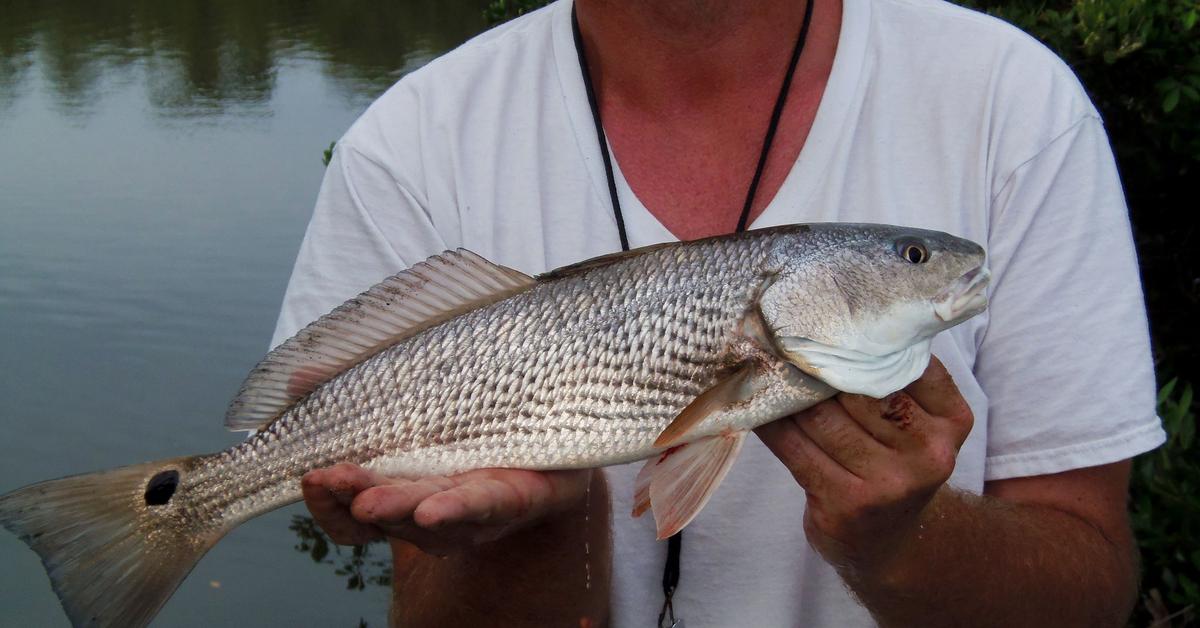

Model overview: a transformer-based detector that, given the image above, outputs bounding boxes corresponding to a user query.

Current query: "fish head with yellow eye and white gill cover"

[758,223,990,397]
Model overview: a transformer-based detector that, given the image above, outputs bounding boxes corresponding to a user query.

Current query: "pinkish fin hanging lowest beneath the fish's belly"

[634,430,746,540]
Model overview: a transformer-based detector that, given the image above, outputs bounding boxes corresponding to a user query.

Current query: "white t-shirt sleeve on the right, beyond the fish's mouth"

[976,115,1165,480]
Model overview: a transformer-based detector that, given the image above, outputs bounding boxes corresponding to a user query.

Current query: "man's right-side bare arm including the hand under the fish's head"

[758,359,1136,627]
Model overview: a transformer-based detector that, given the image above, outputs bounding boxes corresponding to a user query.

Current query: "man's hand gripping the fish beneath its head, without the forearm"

[757,358,973,572]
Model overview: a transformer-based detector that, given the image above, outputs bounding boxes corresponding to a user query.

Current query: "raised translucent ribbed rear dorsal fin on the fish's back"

[226,249,535,430]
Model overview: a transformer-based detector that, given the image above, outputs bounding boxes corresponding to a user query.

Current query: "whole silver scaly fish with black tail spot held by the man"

[0,225,986,626]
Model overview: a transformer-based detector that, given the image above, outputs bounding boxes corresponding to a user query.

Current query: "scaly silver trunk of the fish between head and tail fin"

[206,228,832,516]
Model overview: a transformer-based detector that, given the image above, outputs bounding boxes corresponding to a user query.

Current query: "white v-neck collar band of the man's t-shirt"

[551,0,871,247]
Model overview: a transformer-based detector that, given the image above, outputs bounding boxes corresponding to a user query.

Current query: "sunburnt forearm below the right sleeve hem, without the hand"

[839,486,1136,627]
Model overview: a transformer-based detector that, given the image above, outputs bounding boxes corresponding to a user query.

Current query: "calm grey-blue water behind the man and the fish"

[0,0,484,627]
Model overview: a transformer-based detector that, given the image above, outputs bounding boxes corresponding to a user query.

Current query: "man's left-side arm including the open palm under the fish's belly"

[304,465,612,628]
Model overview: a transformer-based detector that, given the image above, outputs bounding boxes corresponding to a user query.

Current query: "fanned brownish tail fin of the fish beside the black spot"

[0,456,227,627]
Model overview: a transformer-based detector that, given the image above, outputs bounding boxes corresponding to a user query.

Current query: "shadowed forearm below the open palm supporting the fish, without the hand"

[391,472,612,627]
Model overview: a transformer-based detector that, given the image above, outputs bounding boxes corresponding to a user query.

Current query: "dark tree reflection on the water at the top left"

[0,0,482,115]
